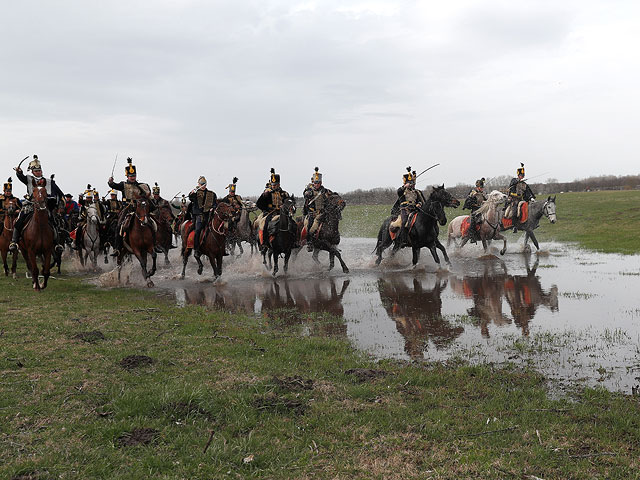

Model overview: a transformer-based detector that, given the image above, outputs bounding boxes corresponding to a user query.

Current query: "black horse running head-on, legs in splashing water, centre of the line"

[262,196,298,277]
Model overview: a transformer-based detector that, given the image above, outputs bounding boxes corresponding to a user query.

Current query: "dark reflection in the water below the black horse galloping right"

[378,275,464,359]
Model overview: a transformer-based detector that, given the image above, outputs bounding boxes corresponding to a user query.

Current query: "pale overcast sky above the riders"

[0,0,640,197]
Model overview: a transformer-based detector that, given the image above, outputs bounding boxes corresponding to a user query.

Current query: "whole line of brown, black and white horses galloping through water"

[0,185,556,290]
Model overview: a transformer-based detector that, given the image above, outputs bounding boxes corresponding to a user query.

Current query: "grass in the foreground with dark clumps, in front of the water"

[0,277,640,480]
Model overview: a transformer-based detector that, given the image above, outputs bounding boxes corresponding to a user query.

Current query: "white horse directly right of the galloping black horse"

[447,190,507,255]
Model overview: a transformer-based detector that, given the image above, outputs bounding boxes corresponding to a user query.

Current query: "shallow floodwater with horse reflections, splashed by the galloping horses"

[103,236,640,393]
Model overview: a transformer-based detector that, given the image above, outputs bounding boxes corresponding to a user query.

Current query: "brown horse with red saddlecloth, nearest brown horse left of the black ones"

[180,202,235,280]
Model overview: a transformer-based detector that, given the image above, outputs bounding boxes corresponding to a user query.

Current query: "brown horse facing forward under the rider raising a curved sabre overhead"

[18,187,55,291]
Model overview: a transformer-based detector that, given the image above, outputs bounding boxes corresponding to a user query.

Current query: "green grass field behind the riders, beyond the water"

[341,190,640,254]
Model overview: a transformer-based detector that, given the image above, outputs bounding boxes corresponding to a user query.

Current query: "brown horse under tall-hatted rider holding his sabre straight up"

[117,199,156,287]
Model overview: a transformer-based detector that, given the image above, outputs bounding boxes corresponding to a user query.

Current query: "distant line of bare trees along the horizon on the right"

[340,175,640,205]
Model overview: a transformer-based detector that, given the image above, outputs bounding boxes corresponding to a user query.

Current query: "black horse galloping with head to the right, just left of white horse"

[374,184,460,268]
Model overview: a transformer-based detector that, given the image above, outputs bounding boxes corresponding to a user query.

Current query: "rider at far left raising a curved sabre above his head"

[9,155,64,252]
